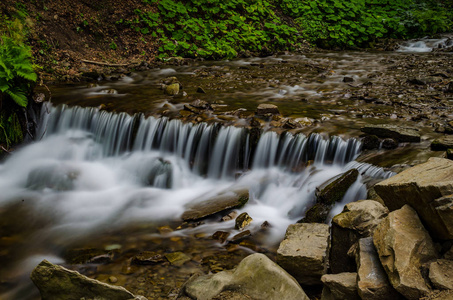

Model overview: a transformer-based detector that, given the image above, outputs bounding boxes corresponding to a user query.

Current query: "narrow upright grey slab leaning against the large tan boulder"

[355,237,402,300]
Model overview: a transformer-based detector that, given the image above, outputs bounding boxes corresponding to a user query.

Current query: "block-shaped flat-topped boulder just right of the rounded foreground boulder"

[277,223,329,285]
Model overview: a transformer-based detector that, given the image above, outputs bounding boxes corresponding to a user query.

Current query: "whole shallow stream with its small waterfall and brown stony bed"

[0,37,453,300]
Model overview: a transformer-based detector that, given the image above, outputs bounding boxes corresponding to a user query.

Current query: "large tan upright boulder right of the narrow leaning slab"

[373,205,438,299]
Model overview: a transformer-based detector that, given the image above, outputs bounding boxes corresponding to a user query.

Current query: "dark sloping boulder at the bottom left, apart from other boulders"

[31,260,146,300]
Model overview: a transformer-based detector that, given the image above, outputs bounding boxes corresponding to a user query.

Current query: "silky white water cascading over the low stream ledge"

[0,105,390,297]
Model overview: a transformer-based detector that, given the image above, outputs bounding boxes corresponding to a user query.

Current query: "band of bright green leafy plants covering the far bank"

[116,0,453,58]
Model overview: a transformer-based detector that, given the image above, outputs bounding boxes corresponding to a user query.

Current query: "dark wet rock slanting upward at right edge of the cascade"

[300,169,359,223]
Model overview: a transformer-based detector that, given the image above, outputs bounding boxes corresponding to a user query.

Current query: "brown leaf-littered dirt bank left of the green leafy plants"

[0,0,158,81]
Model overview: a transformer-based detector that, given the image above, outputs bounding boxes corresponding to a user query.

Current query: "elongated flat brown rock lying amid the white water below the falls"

[182,189,249,221]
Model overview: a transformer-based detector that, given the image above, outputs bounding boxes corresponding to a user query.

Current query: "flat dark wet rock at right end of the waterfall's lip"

[361,124,420,143]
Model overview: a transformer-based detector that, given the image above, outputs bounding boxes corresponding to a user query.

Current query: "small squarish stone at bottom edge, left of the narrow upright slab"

[321,273,360,300]
